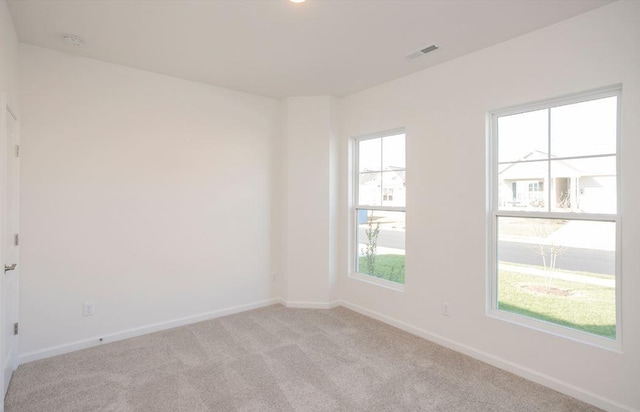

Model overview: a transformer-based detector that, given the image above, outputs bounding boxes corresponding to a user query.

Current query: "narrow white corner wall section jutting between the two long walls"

[282,96,337,307]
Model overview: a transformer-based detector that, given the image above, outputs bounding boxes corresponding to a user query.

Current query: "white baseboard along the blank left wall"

[19,299,282,364]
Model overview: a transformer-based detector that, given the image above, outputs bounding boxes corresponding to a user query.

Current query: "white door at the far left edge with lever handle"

[0,98,20,398]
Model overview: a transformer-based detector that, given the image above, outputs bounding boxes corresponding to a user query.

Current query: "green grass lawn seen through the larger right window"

[498,270,616,339]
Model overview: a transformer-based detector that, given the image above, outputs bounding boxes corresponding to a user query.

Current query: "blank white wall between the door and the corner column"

[20,45,280,359]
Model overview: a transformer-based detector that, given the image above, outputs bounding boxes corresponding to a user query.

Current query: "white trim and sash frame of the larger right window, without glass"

[486,84,623,353]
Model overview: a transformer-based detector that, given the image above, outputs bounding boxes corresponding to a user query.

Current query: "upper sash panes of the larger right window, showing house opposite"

[496,96,618,214]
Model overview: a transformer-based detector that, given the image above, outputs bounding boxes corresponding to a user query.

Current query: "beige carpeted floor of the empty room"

[5,305,598,412]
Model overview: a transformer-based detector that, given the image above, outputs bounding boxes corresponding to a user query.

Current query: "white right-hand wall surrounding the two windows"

[340,1,640,409]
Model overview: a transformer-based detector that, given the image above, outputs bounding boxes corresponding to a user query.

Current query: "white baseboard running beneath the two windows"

[339,301,638,412]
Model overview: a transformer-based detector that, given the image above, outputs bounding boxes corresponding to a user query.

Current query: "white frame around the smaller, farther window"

[347,127,407,292]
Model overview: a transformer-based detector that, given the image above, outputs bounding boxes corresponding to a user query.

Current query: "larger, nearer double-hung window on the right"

[489,89,620,346]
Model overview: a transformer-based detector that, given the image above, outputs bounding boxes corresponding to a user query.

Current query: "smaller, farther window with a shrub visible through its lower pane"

[353,130,406,288]
